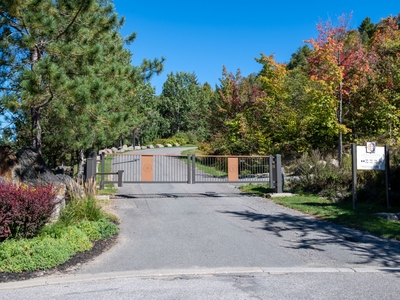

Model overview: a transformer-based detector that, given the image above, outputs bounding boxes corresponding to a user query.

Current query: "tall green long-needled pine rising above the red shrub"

[0,0,164,169]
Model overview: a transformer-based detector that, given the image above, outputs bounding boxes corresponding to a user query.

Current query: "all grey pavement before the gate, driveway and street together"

[0,149,400,299]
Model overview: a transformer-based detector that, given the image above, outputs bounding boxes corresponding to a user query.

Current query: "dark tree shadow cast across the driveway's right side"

[219,211,400,271]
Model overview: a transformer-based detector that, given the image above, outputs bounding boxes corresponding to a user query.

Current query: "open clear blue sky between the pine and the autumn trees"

[114,0,400,94]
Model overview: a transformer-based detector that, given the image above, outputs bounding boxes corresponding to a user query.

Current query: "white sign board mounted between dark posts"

[357,145,385,171]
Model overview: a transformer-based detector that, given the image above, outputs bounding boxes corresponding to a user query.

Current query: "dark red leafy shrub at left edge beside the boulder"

[0,184,57,241]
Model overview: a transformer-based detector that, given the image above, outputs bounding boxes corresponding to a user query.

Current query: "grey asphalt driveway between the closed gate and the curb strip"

[70,149,400,274]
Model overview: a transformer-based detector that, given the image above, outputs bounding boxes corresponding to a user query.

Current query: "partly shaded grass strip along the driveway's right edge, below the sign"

[241,184,400,240]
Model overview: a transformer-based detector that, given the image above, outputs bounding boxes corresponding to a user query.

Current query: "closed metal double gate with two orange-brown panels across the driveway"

[87,154,283,192]
